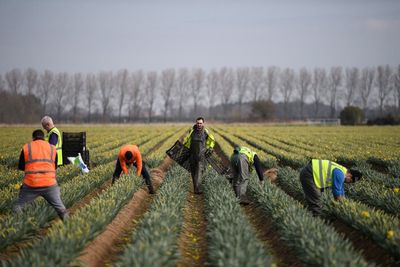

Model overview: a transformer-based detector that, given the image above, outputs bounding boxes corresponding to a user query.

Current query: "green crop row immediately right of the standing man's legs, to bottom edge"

[204,171,274,267]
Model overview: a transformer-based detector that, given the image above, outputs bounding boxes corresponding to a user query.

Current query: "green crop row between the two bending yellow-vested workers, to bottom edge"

[249,176,368,266]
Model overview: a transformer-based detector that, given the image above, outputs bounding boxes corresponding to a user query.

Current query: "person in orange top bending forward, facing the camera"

[112,145,154,194]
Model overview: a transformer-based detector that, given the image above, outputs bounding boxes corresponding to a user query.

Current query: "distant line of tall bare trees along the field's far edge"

[0,65,400,123]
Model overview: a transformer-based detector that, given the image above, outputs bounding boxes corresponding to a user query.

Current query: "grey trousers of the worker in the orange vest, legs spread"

[13,184,68,220]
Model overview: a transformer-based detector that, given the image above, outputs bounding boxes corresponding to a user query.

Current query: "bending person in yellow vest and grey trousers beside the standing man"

[230,145,278,205]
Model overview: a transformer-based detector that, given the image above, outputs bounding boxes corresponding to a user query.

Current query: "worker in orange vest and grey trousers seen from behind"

[13,130,68,220]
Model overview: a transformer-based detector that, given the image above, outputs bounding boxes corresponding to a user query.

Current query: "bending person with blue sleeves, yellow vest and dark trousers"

[300,159,362,215]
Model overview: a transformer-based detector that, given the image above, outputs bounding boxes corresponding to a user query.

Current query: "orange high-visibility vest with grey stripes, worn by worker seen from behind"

[24,140,57,187]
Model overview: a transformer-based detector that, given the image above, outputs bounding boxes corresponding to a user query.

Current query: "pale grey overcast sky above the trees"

[0,0,400,73]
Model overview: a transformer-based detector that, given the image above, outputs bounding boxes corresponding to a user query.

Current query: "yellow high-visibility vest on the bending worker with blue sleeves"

[312,159,347,188]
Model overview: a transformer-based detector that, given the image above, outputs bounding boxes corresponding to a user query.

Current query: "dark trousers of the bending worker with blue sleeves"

[300,163,323,218]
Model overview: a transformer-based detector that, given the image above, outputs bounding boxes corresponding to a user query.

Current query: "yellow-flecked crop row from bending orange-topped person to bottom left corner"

[5,171,142,266]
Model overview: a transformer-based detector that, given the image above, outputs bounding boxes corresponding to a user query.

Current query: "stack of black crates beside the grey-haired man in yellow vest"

[62,132,90,167]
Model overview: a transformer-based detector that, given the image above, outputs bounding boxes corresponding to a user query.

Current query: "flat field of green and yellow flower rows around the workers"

[0,124,400,266]
